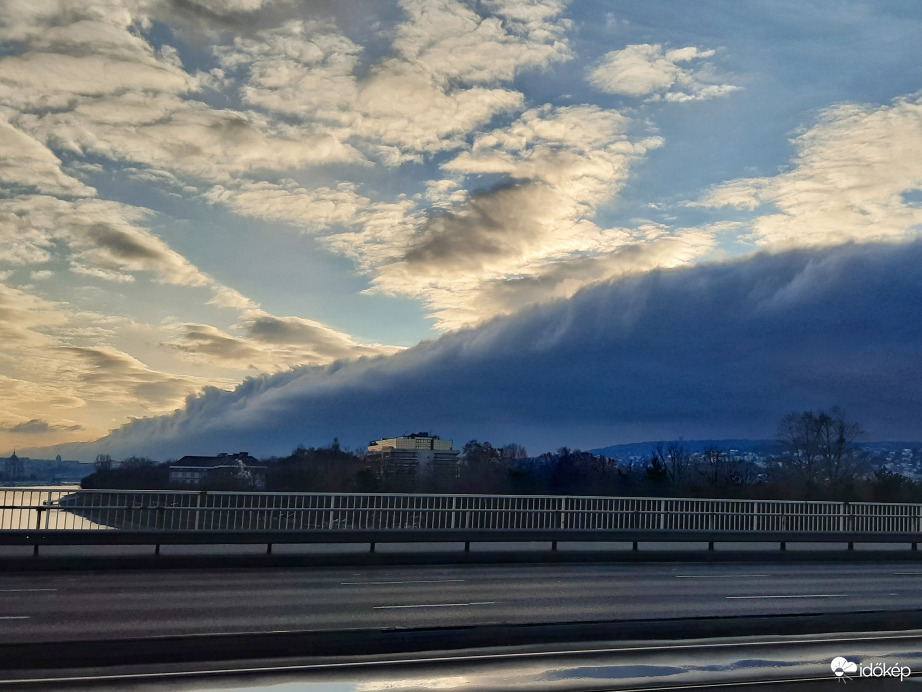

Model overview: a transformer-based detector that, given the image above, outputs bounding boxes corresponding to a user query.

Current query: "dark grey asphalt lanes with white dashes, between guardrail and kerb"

[0,562,922,644]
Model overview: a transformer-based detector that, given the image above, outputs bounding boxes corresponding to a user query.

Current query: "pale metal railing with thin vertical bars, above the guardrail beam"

[0,488,922,540]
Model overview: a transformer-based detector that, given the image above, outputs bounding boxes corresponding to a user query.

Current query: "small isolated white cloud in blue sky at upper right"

[589,43,740,101]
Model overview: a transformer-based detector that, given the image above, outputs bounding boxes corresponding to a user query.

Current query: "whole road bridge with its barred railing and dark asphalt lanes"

[0,488,922,689]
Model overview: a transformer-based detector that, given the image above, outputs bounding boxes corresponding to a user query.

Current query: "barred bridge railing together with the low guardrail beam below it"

[0,488,922,551]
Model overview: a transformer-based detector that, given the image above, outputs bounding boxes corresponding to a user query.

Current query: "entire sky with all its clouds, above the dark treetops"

[0,0,922,459]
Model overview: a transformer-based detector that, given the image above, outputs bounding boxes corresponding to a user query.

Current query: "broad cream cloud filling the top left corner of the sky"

[0,0,361,183]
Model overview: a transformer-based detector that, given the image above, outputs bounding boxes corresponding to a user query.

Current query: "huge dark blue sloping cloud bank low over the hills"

[41,242,922,458]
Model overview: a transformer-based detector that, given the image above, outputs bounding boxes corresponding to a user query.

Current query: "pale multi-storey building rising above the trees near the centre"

[368,432,461,479]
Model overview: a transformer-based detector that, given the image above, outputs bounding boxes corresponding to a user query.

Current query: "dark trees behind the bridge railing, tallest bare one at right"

[82,407,922,502]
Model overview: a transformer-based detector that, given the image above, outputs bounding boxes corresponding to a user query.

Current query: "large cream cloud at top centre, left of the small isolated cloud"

[217,0,570,166]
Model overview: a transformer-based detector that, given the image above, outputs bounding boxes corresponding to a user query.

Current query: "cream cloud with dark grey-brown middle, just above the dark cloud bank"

[356,105,688,328]
